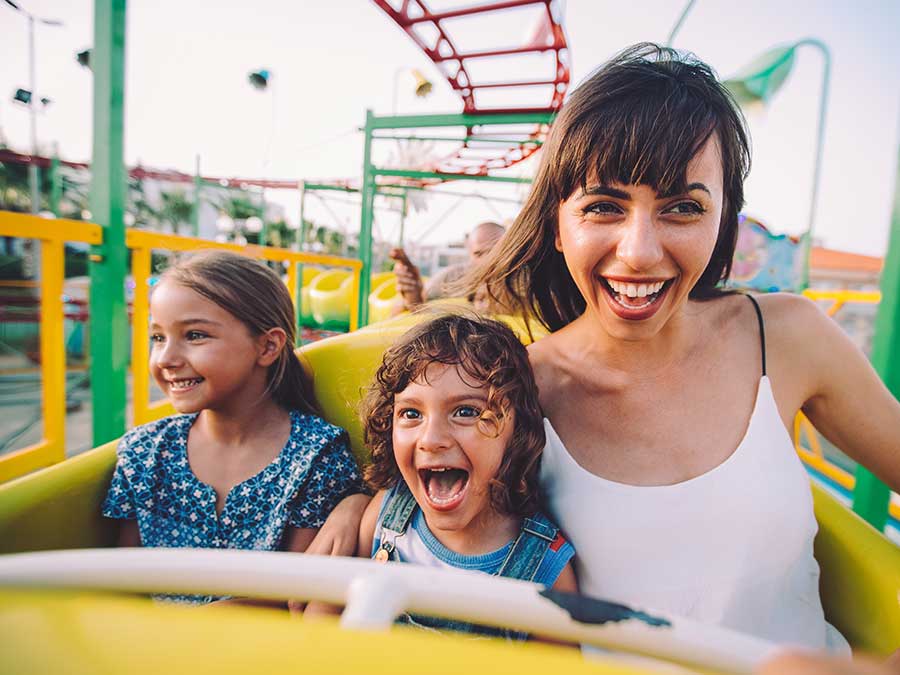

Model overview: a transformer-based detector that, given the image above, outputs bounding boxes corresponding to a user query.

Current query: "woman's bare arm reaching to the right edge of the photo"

[764,296,900,491]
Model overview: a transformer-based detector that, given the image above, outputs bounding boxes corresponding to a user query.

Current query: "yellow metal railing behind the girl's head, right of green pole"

[125,230,362,426]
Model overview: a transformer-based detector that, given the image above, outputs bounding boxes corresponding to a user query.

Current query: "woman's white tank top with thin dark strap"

[541,375,849,651]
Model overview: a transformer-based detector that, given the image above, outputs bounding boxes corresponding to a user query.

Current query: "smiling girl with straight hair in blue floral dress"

[103,252,360,600]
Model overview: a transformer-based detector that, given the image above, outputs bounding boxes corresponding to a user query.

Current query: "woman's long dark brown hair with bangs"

[468,43,750,330]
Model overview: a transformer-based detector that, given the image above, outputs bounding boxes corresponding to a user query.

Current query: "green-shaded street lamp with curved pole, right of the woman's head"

[724,38,831,288]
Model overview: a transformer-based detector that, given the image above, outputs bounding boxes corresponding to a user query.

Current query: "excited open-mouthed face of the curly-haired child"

[392,363,515,550]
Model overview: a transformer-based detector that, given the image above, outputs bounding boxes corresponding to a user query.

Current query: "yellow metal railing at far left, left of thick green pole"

[0,211,103,482]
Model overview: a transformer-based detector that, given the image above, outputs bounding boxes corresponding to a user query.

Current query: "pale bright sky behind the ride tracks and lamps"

[0,0,900,255]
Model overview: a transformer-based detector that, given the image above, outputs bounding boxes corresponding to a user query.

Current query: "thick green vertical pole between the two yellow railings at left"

[90,0,128,446]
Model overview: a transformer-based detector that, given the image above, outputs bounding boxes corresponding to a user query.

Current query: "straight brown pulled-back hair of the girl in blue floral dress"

[160,251,316,413]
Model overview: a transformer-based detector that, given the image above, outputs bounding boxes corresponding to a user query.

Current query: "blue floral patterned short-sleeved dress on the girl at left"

[103,411,361,601]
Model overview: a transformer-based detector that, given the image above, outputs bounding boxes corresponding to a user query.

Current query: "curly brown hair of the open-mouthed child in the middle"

[362,314,545,516]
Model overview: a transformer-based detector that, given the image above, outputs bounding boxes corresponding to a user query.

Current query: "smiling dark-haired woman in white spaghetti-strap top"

[471,44,900,649]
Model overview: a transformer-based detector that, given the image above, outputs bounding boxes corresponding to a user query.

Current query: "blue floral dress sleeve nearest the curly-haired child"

[288,433,362,528]
